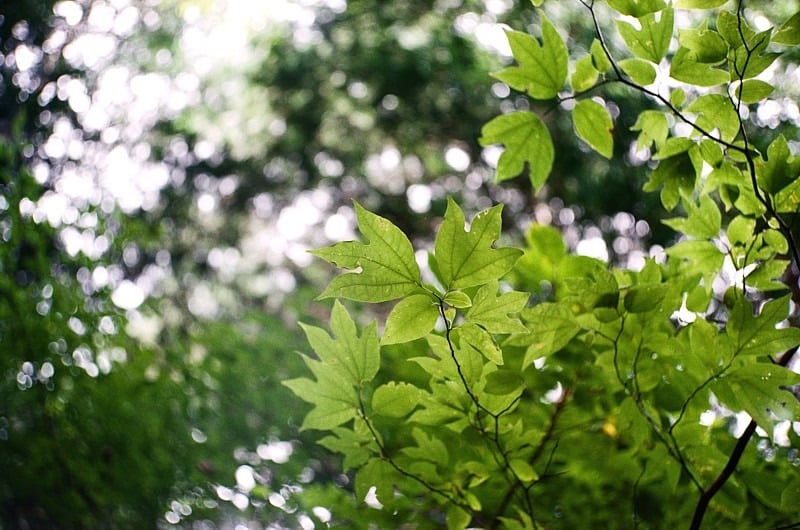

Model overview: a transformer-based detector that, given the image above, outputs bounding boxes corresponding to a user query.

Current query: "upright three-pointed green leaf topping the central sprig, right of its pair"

[434,198,522,290]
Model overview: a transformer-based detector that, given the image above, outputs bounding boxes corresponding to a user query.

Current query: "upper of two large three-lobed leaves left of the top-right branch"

[492,15,568,99]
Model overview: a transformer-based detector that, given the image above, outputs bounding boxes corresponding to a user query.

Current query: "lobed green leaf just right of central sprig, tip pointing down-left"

[514,303,580,370]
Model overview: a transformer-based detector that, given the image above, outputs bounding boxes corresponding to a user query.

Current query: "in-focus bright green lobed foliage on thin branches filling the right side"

[286,0,800,529]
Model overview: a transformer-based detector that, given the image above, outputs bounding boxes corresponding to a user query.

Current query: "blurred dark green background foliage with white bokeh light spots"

[0,0,800,528]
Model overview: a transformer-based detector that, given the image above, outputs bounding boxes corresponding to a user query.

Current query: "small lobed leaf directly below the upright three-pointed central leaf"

[467,281,529,333]
